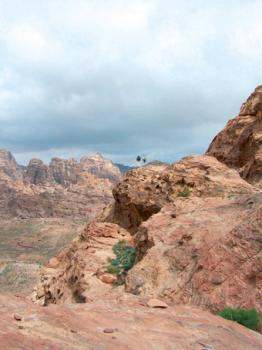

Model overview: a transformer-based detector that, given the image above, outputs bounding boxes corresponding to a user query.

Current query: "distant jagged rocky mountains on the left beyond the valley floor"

[0,150,121,219]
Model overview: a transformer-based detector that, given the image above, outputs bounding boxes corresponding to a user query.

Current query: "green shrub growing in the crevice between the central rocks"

[107,241,136,284]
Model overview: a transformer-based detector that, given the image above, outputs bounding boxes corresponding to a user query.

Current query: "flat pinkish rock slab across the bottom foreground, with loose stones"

[0,289,262,350]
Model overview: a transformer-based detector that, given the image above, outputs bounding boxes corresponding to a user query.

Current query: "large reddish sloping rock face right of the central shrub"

[126,194,262,312]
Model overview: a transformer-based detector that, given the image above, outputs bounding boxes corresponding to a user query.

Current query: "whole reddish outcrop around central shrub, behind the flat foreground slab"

[36,156,262,312]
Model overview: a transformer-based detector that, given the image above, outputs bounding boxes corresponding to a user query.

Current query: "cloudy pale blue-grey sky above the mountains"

[0,0,262,165]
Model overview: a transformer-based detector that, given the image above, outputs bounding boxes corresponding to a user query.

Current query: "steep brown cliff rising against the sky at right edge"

[206,86,262,188]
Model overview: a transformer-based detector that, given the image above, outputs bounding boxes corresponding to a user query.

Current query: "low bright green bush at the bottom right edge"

[218,308,259,330]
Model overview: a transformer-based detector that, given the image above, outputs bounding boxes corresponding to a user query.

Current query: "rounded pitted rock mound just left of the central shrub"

[34,222,132,305]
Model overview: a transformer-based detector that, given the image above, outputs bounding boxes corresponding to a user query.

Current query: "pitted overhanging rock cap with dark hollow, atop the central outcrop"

[99,156,253,233]
